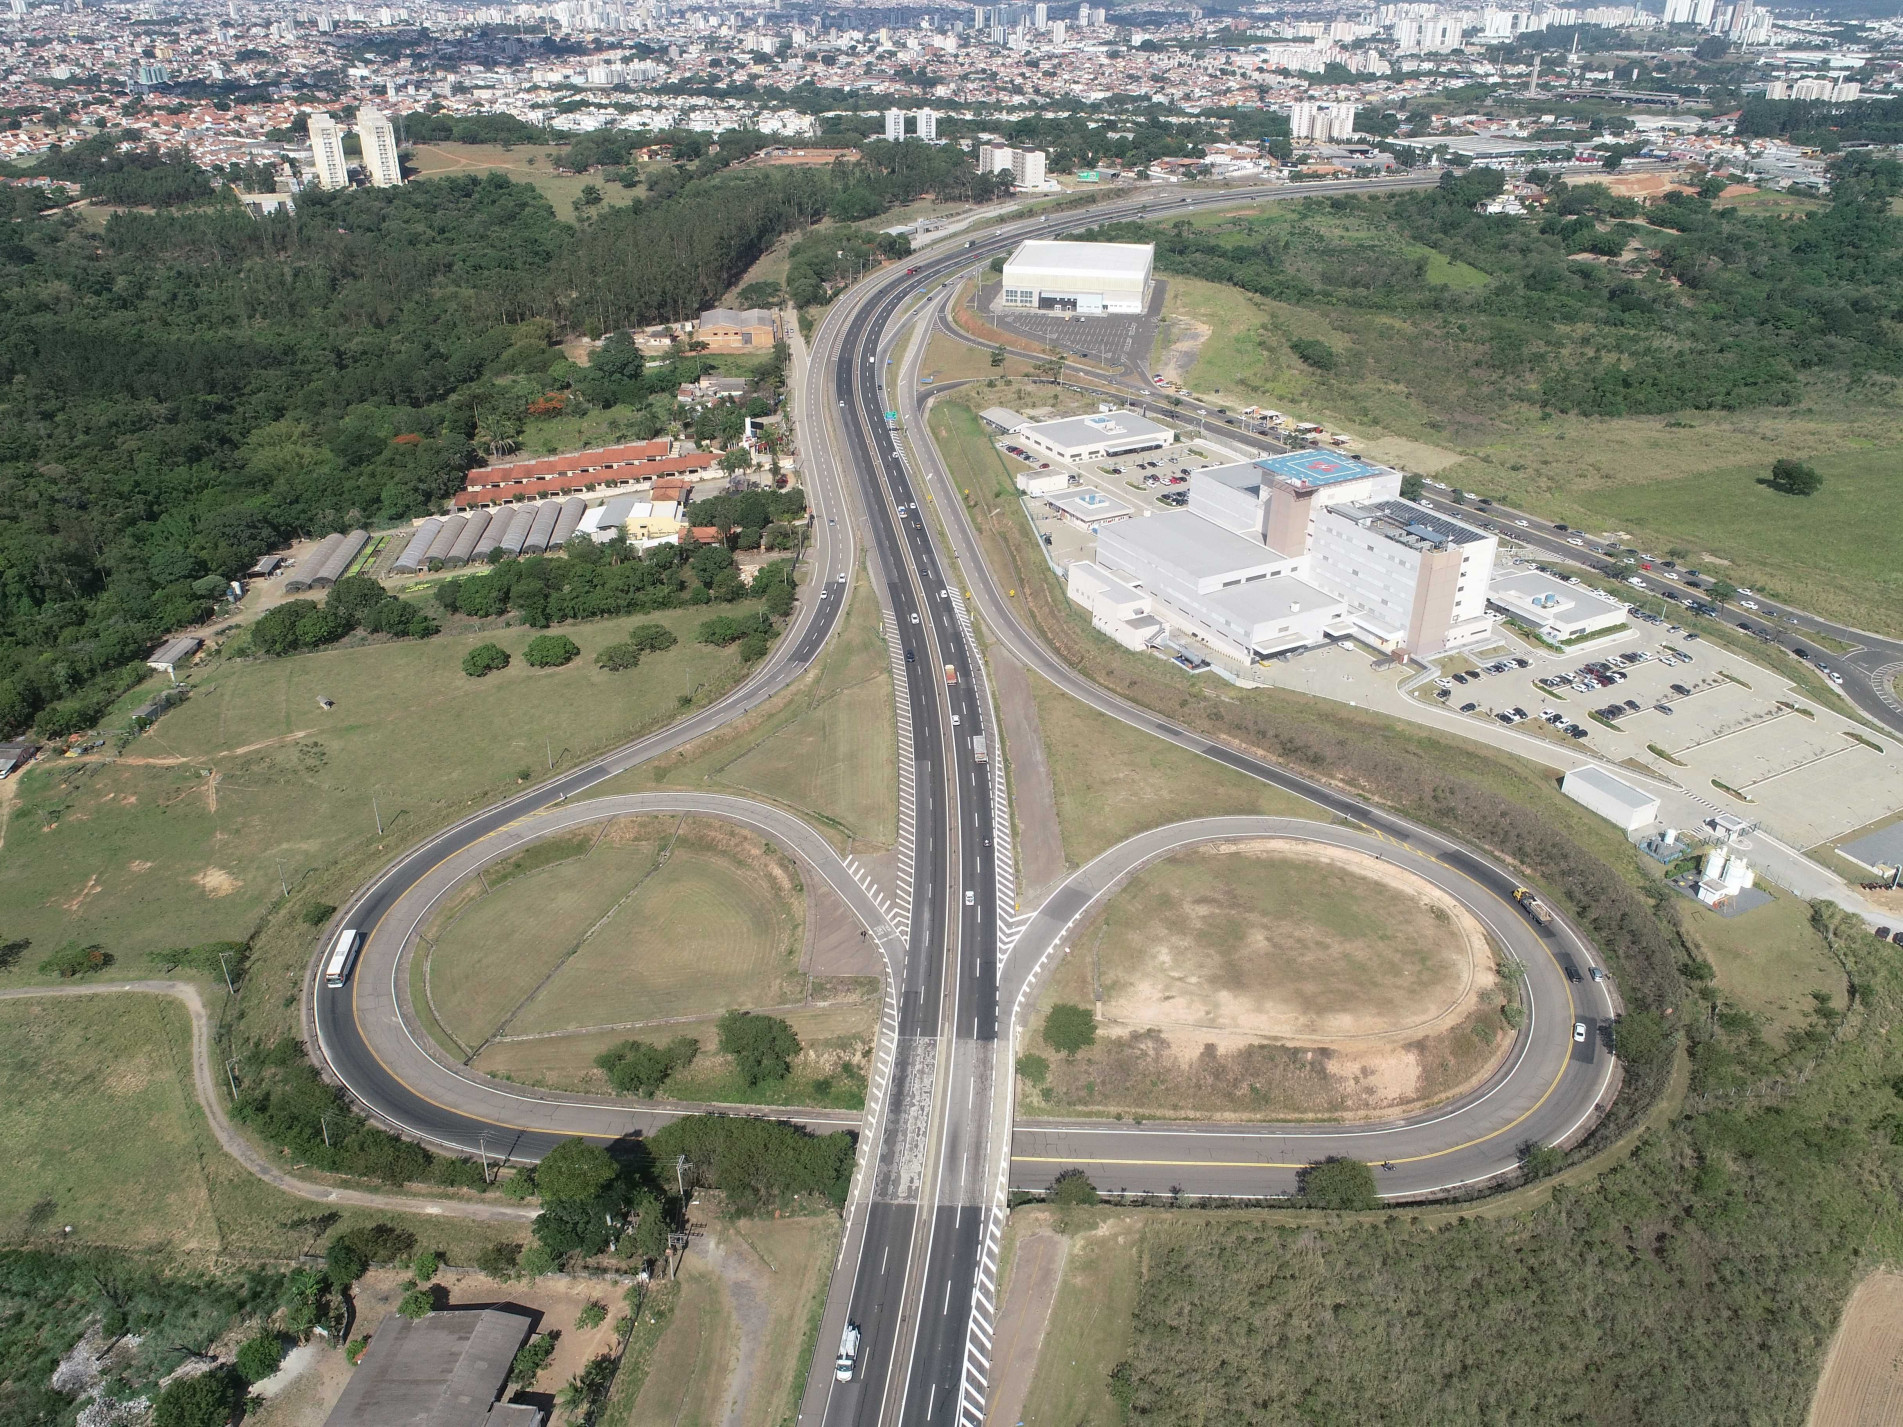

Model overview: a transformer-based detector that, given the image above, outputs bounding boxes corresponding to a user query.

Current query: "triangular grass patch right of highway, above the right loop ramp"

[1031,674,1321,866]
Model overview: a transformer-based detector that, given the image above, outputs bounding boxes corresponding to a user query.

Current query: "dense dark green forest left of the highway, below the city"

[0,143,1004,734]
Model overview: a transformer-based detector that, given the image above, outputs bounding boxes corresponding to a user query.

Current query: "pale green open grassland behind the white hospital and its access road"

[1126,204,1903,632]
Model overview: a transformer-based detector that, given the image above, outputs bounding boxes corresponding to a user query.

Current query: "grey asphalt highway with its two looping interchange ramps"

[306,179,1616,1423]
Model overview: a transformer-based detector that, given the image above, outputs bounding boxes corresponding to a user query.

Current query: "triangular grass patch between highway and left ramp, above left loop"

[639,577,898,849]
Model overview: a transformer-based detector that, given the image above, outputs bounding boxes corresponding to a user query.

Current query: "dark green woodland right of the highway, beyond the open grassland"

[1087,150,1903,417]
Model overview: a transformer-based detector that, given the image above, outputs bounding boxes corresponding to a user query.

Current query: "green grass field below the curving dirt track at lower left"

[0,993,521,1263]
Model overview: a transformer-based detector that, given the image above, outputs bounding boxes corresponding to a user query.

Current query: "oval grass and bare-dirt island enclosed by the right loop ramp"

[1020,839,1513,1117]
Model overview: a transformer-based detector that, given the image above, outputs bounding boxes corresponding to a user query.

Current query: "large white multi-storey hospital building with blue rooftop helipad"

[1094,451,1498,662]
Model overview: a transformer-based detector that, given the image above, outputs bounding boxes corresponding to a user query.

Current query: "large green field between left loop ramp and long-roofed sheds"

[0,611,742,978]
